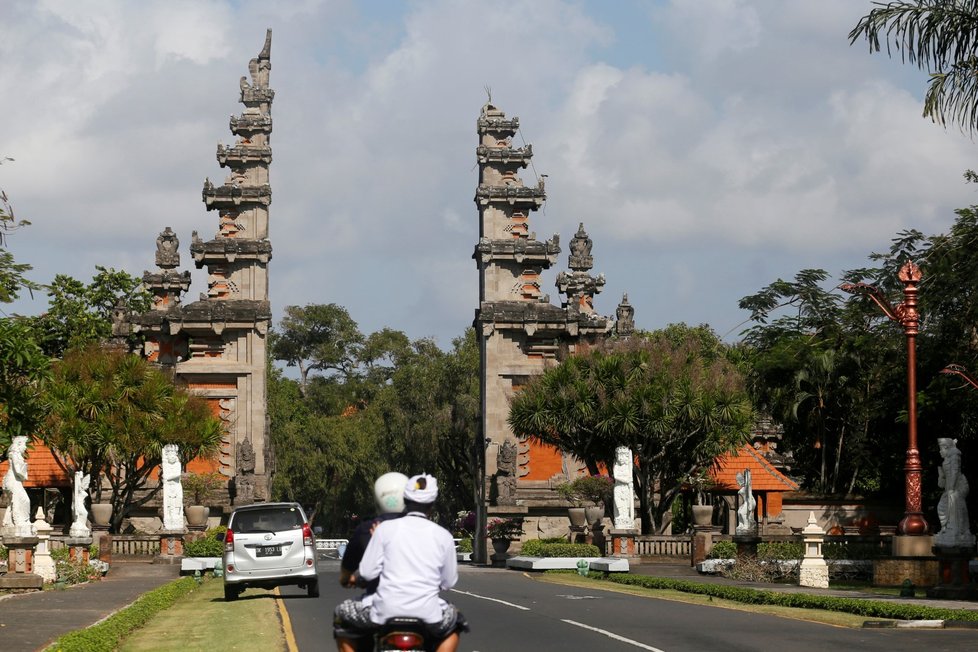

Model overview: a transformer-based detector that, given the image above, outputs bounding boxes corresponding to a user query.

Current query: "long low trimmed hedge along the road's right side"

[603,574,978,621]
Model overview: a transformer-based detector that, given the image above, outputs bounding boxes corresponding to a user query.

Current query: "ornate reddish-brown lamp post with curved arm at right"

[839,261,928,536]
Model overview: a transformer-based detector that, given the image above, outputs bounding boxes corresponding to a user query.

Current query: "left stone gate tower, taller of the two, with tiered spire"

[133,30,275,504]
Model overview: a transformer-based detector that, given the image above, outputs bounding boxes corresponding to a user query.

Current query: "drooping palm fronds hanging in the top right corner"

[849,0,978,134]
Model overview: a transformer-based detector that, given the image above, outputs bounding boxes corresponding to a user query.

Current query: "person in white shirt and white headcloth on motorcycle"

[334,474,465,652]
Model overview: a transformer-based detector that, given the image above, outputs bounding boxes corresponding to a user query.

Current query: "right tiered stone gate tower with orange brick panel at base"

[473,104,614,559]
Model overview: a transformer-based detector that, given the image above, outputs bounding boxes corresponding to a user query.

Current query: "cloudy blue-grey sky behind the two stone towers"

[0,0,978,348]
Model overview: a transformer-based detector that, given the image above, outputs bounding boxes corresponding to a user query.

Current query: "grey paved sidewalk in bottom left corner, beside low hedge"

[0,562,180,652]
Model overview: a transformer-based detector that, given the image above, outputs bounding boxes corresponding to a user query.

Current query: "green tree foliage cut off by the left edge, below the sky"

[0,318,50,459]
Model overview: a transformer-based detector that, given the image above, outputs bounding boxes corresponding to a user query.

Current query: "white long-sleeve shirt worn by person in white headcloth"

[359,512,458,624]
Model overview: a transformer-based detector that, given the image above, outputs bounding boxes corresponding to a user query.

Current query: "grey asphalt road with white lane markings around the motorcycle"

[282,562,978,652]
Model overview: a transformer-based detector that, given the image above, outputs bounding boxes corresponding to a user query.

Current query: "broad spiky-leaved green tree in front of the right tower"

[509,324,753,534]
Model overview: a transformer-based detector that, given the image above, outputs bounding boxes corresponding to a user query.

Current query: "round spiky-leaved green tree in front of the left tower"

[41,344,223,532]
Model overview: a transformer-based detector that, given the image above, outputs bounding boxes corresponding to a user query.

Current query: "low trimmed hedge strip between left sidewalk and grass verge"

[47,577,197,652]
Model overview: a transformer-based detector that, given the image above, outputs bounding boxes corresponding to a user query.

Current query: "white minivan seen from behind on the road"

[223,503,319,600]
